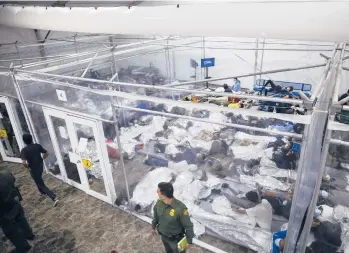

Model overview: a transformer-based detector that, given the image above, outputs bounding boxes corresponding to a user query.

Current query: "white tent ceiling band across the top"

[0,1,349,41]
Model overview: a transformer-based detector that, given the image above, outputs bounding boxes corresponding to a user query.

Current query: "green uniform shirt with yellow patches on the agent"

[152,198,194,244]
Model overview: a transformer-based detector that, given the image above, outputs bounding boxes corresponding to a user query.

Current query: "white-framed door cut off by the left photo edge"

[0,97,25,163]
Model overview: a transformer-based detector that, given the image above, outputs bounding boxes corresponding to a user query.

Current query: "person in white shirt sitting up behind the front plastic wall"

[233,192,273,231]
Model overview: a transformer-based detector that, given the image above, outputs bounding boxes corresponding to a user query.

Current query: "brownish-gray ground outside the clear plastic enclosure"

[0,162,250,253]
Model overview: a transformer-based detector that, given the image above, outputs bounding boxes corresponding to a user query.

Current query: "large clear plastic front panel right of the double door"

[113,98,301,252]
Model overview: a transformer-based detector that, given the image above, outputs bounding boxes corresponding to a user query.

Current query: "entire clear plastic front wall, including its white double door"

[12,74,307,252]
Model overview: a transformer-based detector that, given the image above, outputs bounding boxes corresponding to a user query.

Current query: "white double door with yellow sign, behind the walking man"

[43,108,116,204]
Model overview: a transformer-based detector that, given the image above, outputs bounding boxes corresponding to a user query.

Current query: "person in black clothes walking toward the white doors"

[21,134,58,206]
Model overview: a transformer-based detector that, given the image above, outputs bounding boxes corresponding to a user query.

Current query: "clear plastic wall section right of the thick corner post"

[300,127,349,253]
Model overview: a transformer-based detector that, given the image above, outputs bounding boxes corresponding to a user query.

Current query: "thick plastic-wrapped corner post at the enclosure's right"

[284,45,339,253]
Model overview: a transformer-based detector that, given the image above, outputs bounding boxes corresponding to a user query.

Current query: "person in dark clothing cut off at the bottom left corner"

[0,171,35,253]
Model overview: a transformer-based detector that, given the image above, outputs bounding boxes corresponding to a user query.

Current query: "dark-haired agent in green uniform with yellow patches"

[152,183,194,253]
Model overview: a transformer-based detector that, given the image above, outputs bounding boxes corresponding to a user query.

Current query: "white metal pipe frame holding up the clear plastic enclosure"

[0,38,349,253]
